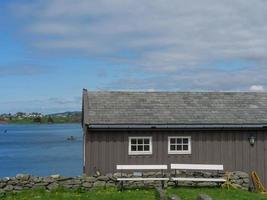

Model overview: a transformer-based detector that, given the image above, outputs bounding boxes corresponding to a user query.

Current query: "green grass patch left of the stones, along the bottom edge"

[0,188,155,200]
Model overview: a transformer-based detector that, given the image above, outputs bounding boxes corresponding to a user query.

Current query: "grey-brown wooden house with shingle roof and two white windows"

[82,90,267,185]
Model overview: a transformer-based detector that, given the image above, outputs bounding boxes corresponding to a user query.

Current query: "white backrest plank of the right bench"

[171,164,223,171]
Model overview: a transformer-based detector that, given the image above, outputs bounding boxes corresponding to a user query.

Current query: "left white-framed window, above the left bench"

[129,137,152,155]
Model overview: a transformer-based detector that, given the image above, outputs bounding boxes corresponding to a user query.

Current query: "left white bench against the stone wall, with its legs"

[117,165,169,189]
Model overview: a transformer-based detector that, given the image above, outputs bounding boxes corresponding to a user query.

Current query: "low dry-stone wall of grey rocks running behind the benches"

[0,171,249,193]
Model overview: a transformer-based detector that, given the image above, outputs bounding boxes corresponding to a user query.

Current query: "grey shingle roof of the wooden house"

[83,91,267,125]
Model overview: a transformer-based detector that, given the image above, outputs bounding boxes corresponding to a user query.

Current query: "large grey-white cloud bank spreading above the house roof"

[7,0,267,90]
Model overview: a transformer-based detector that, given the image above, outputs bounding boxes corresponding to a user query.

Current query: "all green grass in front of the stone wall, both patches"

[0,187,267,200]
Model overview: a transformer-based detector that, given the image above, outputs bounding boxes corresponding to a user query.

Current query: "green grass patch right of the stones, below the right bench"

[167,187,267,200]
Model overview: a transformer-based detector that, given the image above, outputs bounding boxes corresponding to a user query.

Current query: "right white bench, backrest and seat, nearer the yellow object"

[171,164,226,183]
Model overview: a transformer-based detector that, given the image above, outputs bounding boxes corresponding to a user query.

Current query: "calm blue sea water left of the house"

[0,124,82,177]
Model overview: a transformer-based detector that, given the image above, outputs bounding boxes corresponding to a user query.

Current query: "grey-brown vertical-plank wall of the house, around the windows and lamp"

[85,129,267,185]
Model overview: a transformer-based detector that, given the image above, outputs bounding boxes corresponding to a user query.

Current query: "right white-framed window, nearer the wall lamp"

[168,136,191,154]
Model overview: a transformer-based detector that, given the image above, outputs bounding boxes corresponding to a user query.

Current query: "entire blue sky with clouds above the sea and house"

[0,0,267,113]
